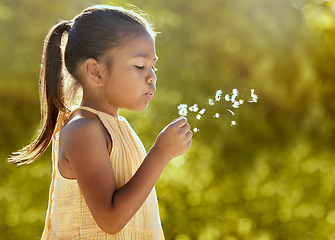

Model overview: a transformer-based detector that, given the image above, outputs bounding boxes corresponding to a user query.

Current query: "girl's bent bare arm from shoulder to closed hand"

[64,118,192,234]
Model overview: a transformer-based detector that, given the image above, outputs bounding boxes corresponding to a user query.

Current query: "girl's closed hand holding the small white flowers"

[153,117,193,161]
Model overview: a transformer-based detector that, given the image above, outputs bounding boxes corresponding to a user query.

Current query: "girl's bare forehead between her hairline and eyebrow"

[114,34,158,61]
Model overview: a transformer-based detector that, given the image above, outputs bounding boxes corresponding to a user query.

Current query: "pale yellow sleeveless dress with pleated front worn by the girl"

[41,107,164,240]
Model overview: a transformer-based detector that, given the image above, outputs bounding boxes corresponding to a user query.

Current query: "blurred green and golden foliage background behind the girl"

[0,0,335,240]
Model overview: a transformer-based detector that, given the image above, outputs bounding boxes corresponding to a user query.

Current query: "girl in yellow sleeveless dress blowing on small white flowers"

[10,6,192,240]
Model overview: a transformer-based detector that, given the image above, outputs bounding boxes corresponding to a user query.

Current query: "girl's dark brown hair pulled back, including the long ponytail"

[8,5,156,165]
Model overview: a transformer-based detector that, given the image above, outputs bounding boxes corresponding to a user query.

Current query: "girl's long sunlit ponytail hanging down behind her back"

[8,21,72,166]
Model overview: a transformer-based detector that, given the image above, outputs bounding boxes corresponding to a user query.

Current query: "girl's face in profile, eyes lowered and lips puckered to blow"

[100,34,157,111]
